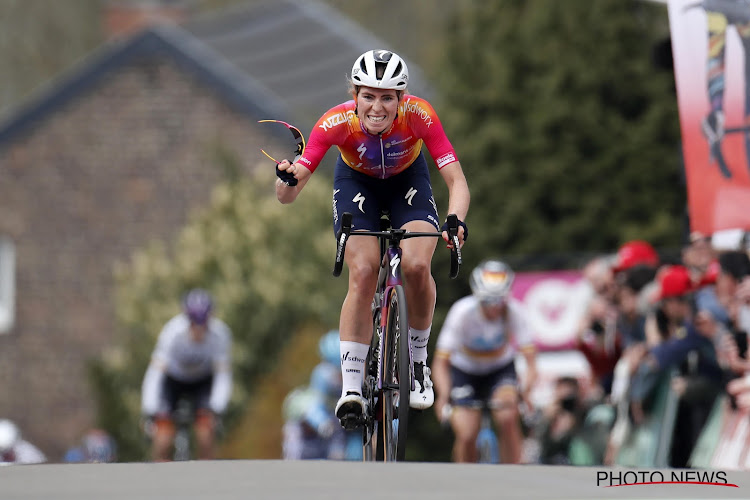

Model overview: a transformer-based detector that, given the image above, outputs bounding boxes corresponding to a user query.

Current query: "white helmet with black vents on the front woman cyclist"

[352,50,409,90]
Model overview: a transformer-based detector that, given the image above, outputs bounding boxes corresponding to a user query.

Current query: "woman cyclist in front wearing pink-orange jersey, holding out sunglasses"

[276,50,469,418]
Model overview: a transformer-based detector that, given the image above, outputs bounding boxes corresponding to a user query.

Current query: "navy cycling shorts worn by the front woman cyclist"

[333,153,440,233]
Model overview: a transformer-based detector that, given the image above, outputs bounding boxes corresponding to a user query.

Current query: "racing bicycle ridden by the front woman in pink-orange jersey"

[333,211,462,462]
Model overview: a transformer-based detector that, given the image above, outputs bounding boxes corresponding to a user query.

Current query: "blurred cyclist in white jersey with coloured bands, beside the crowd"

[433,260,537,463]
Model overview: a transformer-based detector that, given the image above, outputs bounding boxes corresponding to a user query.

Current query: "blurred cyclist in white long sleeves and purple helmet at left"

[141,289,232,461]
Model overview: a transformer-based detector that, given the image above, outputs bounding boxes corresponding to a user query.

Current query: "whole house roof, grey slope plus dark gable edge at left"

[0,0,430,146]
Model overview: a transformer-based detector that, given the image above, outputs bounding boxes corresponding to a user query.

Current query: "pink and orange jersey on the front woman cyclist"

[299,94,457,179]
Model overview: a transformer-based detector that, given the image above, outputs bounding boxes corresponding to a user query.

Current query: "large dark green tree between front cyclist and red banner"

[438,0,685,262]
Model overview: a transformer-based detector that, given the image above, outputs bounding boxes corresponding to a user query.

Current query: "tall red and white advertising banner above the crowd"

[668,0,750,235]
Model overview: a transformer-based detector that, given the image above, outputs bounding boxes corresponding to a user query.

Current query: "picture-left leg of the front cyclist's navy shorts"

[333,157,383,234]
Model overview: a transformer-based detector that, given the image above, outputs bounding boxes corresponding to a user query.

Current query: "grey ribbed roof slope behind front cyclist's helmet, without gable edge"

[185,0,432,130]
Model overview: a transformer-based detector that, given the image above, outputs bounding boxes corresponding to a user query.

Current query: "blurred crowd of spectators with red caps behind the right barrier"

[527,233,750,469]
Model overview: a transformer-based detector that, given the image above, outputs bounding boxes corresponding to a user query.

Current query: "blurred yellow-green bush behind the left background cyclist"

[91,161,346,460]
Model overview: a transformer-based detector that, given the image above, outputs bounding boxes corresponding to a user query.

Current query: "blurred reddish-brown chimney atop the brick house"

[102,0,188,39]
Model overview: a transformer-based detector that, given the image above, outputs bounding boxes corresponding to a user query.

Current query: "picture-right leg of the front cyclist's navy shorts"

[386,154,440,230]
